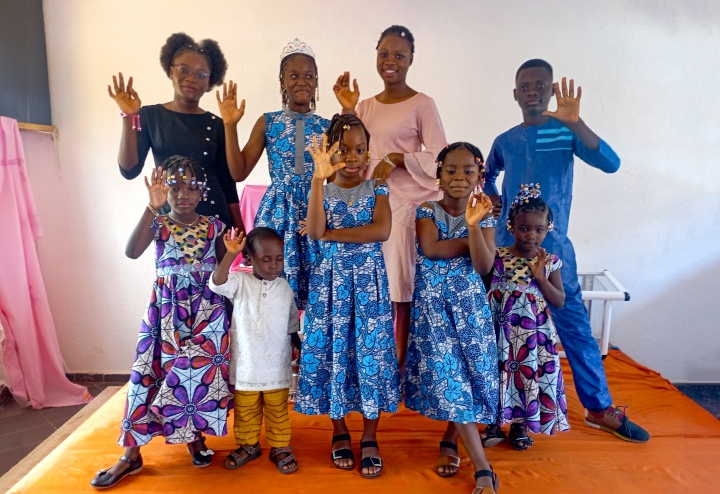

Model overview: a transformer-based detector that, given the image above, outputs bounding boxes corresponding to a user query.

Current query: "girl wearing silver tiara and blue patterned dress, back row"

[217,38,329,310]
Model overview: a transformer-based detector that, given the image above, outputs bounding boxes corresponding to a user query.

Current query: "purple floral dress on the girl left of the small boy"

[118,216,232,447]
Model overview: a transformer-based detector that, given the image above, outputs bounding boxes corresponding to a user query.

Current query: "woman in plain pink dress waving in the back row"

[333,26,447,378]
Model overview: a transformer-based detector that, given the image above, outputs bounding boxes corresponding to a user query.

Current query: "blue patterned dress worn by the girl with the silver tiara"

[255,109,330,310]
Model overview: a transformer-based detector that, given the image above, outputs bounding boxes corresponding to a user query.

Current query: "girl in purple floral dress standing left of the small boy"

[91,156,232,489]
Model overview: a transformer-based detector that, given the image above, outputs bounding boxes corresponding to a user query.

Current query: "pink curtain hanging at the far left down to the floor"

[0,117,90,408]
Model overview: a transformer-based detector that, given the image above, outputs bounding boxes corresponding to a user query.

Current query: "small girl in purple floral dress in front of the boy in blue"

[483,184,570,451]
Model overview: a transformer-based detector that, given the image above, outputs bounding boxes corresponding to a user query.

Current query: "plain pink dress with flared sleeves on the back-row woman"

[357,93,447,302]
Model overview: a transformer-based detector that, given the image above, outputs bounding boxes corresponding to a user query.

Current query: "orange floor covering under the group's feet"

[9,350,720,494]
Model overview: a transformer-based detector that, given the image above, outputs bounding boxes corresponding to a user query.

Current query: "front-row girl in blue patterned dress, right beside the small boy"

[295,115,400,478]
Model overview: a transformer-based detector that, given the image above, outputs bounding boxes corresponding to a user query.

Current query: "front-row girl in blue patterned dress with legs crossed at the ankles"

[405,142,498,494]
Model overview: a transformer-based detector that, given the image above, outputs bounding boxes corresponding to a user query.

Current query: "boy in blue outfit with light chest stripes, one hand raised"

[484,59,650,443]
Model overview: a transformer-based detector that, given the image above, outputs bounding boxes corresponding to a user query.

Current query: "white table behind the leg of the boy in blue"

[560,269,630,359]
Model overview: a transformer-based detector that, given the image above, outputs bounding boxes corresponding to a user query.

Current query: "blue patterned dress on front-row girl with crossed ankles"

[405,202,499,424]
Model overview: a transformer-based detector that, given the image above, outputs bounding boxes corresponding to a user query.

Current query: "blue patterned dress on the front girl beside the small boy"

[295,180,402,420]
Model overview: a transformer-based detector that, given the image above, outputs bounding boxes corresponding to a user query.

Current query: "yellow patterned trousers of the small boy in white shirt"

[233,388,290,448]
